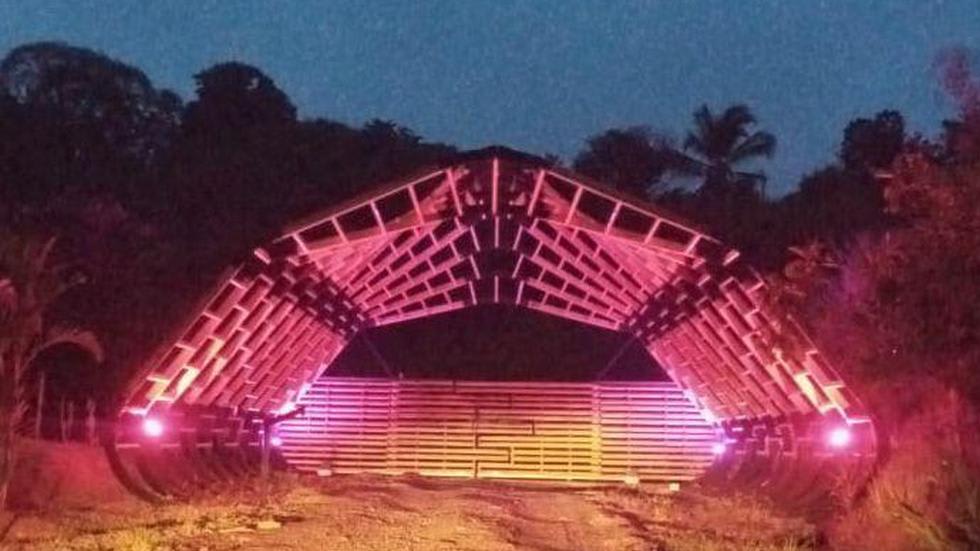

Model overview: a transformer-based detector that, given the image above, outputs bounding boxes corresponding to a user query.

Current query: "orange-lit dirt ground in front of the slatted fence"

[0,476,814,551]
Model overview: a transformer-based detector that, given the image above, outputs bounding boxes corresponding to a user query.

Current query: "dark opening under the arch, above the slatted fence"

[325,305,670,382]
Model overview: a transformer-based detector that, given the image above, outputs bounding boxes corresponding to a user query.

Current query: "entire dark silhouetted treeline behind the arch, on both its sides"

[0,43,980,402]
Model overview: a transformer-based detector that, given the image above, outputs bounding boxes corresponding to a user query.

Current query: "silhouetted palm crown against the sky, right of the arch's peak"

[683,104,776,194]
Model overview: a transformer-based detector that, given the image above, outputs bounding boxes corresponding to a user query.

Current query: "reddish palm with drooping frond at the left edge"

[0,230,102,510]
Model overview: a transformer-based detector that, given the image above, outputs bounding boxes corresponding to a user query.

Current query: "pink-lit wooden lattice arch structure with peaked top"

[113,148,874,496]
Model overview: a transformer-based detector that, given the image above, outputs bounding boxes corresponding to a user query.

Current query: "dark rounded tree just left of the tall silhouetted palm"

[572,126,684,199]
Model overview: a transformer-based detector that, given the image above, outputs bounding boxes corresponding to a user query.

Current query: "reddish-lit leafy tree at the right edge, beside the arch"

[786,152,980,400]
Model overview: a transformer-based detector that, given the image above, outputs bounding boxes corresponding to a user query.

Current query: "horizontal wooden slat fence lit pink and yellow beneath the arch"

[279,378,717,481]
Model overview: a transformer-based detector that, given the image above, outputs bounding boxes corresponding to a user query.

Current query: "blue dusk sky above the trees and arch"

[0,0,980,195]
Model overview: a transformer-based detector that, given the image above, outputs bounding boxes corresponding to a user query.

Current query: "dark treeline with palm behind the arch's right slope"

[573,105,908,269]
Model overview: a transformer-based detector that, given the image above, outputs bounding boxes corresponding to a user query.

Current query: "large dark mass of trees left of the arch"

[0,43,454,398]
